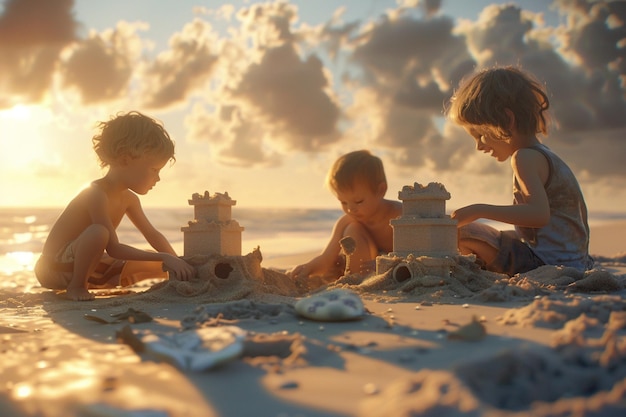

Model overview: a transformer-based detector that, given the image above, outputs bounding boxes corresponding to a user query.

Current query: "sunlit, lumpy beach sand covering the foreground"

[0,223,626,417]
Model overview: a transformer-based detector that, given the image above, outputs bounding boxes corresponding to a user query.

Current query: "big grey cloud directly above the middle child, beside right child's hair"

[332,9,474,169]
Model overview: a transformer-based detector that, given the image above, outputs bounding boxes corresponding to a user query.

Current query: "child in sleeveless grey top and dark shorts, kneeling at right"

[446,67,593,276]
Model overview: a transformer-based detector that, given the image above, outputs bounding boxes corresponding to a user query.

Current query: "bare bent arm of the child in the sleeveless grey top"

[451,149,550,228]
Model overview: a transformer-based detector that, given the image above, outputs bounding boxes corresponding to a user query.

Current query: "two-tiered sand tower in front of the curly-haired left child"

[180,191,244,256]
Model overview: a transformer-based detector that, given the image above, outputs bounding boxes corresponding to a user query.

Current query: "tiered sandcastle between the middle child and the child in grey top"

[376,182,458,280]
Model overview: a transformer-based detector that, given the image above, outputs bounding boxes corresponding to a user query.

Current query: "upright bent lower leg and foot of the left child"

[67,224,109,301]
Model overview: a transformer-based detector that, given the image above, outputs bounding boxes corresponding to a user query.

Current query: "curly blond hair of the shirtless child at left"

[92,111,176,168]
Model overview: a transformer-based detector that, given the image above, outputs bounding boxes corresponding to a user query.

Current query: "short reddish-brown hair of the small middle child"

[326,150,387,193]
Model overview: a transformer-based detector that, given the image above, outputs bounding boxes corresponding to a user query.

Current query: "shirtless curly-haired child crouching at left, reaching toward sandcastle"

[35,112,195,300]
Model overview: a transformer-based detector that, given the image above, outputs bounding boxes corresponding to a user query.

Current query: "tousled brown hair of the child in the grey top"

[446,66,550,140]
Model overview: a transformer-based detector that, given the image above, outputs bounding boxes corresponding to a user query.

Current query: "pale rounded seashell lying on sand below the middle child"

[294,289,365,321]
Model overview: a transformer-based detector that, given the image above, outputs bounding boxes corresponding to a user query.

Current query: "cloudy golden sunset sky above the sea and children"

[0,0,626,213]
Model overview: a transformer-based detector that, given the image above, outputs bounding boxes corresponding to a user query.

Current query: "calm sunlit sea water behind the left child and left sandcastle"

[0,207,342,275]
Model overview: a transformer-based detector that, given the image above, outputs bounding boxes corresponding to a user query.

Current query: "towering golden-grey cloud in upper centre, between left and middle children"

[186,3,341,166]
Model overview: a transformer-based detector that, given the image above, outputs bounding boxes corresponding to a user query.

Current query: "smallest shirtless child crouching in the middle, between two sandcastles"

[288,150,402,281]
